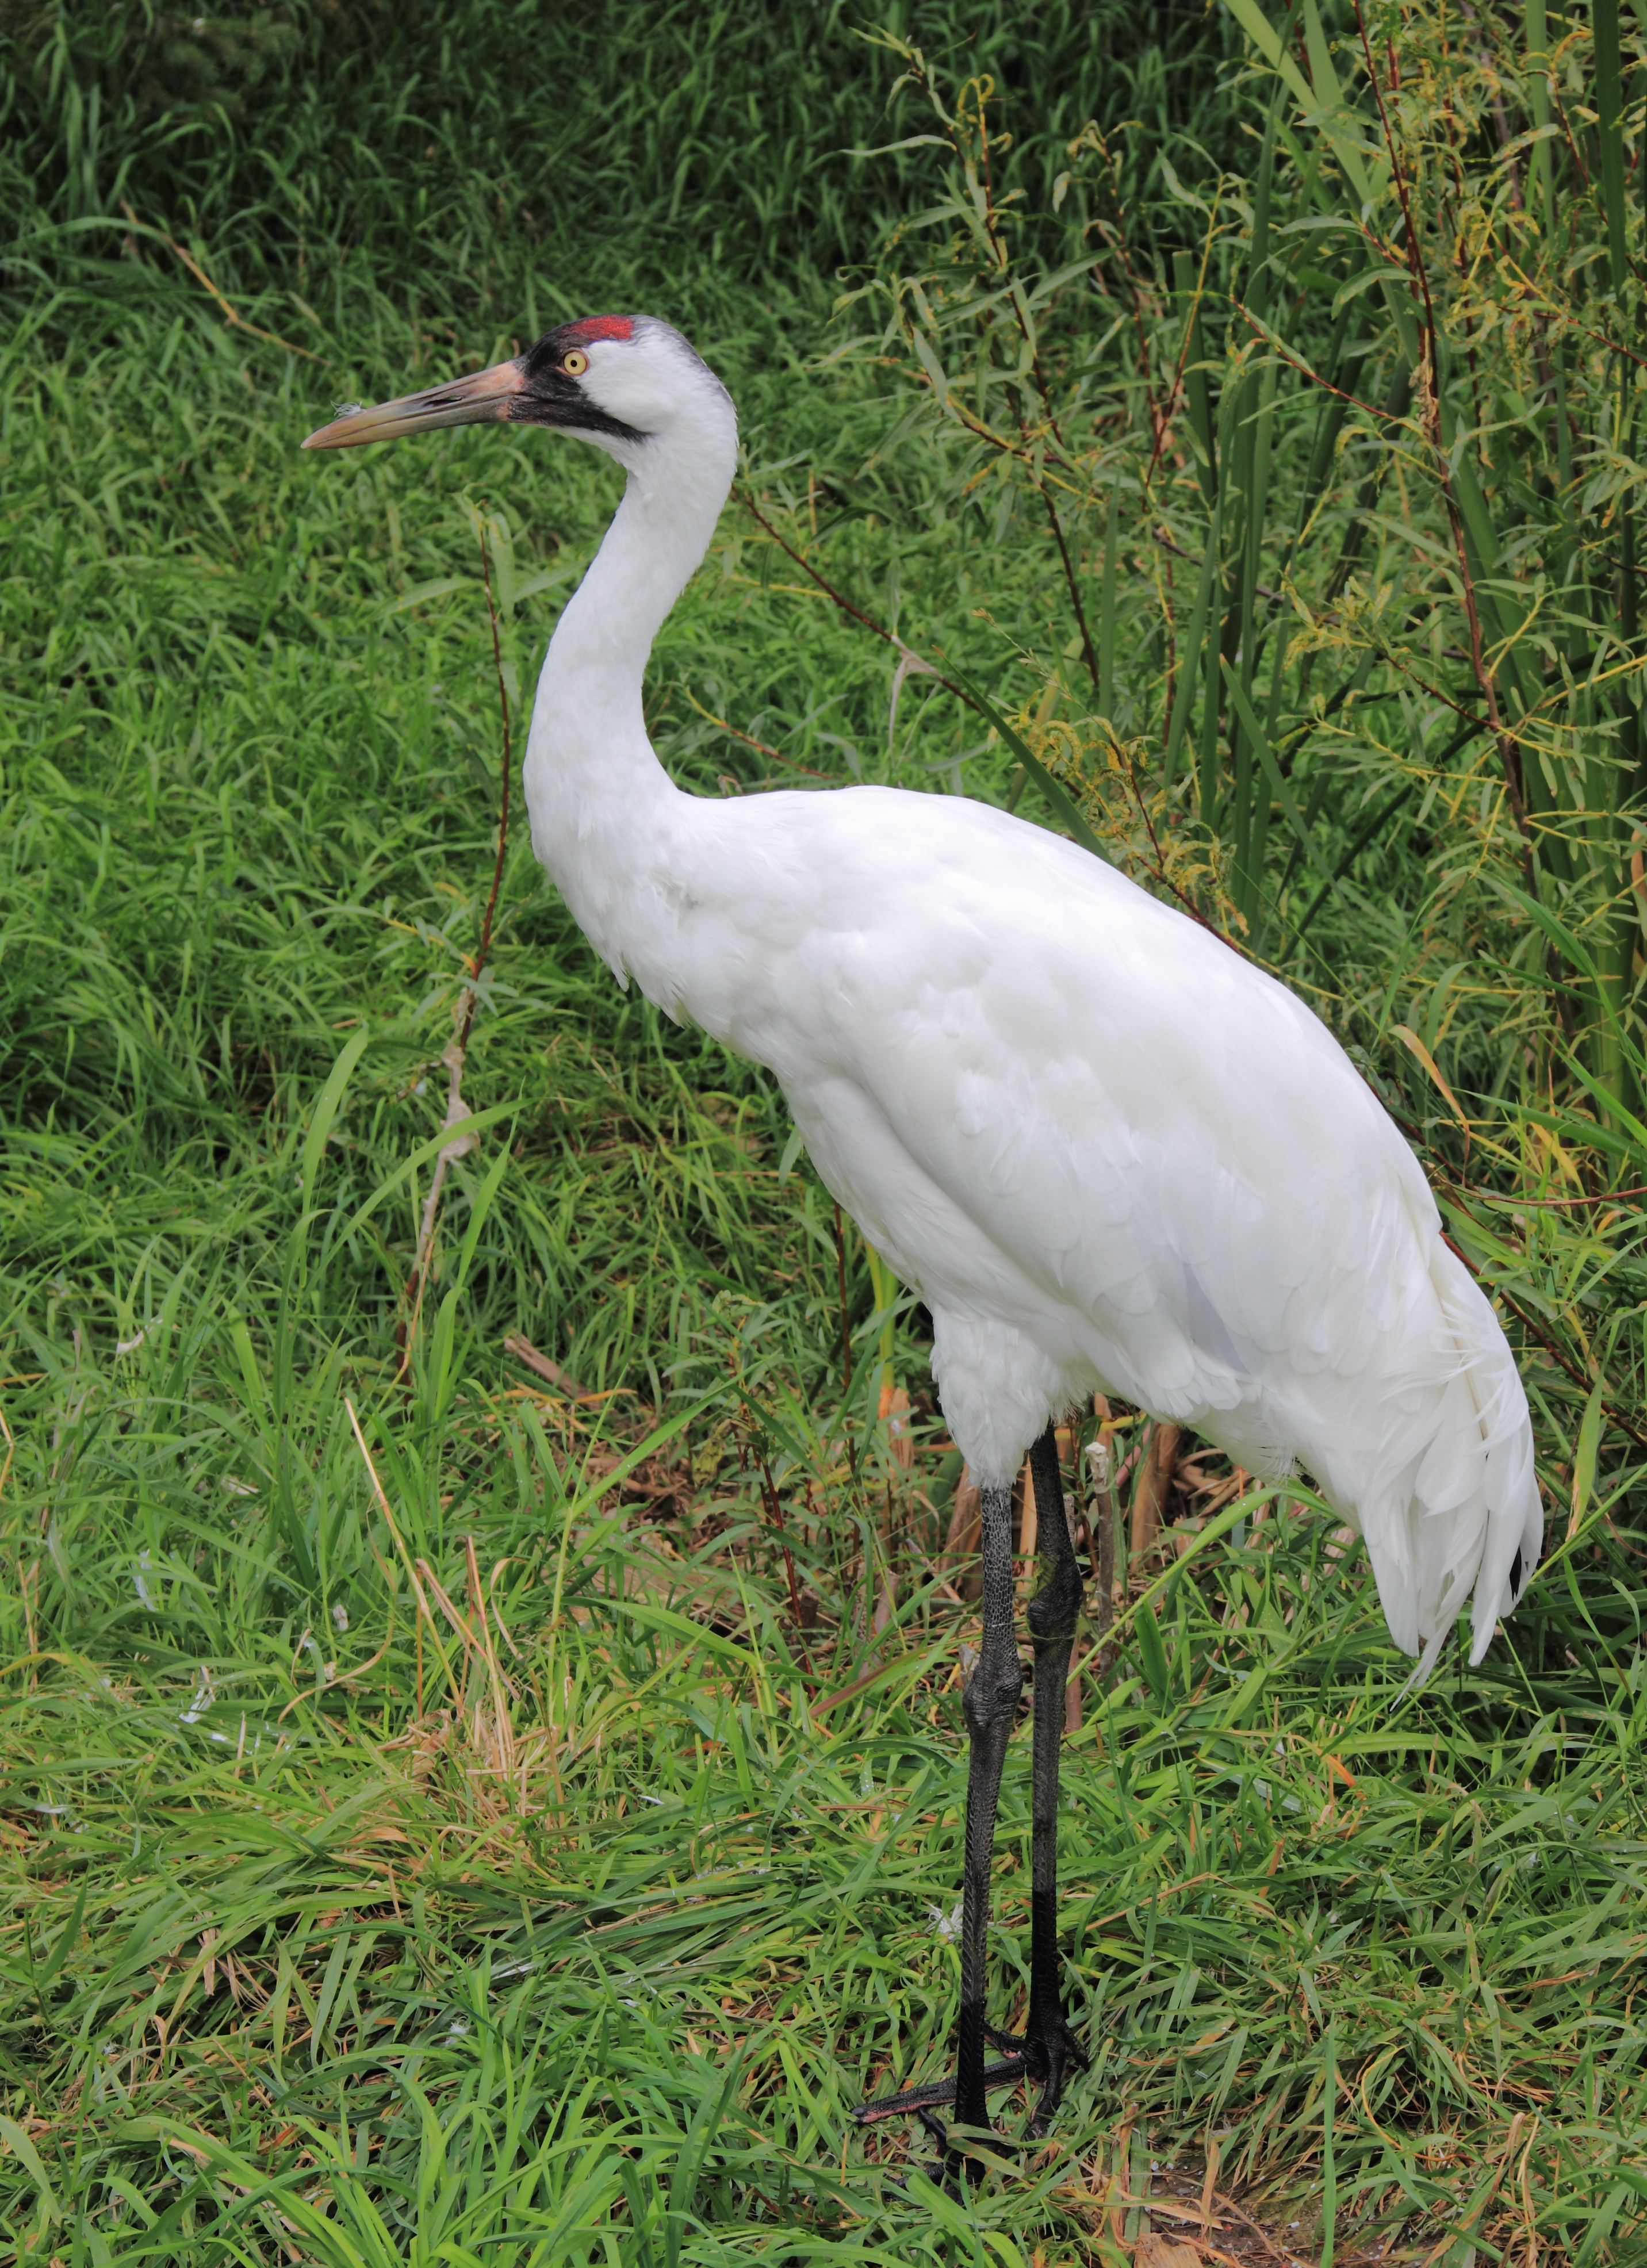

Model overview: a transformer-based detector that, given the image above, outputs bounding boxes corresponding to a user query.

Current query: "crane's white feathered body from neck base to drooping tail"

[653,790,1543,1658]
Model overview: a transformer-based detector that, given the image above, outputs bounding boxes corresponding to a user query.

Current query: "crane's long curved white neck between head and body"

[524,417,735,982]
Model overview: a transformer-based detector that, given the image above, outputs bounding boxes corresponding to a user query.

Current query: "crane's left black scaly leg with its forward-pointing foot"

[853,1488,1025,2173]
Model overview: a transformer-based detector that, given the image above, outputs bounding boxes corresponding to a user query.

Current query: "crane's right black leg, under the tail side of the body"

[1025,1427,1085,2134]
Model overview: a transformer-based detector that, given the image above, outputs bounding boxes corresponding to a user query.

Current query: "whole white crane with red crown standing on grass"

[304,315,1543,2159]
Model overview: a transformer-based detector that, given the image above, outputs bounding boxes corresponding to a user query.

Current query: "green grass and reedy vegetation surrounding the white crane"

[0,0,1647,2268]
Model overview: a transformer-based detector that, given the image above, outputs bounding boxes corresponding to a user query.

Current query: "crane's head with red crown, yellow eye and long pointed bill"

[304,315,735,474]
